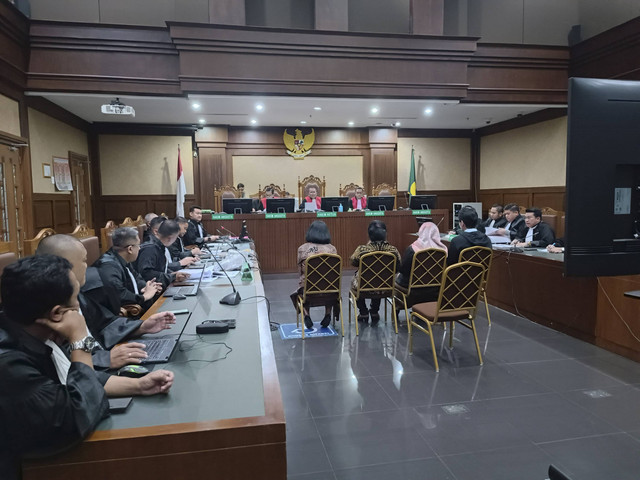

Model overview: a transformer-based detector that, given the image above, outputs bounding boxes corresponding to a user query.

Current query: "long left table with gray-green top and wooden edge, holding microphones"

[23,248,286,480]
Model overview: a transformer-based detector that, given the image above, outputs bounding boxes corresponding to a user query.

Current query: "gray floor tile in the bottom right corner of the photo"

[540,433,640,480]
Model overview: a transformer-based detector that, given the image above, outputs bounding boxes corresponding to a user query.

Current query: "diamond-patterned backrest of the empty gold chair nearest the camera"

[436,262,484,318]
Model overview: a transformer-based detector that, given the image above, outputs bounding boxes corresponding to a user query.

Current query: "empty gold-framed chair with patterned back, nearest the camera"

[409,262,485,372]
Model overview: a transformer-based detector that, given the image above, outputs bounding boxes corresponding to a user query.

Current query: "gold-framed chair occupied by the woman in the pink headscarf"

[394,248,447,333]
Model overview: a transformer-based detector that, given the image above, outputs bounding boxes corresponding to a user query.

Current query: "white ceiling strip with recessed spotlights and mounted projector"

[32,92,566,129]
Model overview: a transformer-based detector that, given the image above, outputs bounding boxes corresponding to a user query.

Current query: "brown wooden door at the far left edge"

[0,144,25,256]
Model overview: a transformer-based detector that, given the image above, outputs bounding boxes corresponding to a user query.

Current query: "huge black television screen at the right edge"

[564,78,640,276]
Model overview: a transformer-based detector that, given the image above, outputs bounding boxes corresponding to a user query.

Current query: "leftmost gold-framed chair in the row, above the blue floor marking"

[296,253,344,340]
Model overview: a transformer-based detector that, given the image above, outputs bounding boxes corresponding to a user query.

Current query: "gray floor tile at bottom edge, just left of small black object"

[440,445,556,480]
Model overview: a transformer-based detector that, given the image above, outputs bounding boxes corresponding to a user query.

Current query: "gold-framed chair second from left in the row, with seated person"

[349,251,398,335]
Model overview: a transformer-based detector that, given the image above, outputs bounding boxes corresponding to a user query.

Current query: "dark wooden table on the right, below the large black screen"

[487,250,640,361]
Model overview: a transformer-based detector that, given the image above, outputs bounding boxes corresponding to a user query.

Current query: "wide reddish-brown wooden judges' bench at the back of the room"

[203,210,449,273]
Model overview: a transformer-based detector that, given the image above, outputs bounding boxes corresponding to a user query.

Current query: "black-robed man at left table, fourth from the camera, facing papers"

[135,220,195,289]
